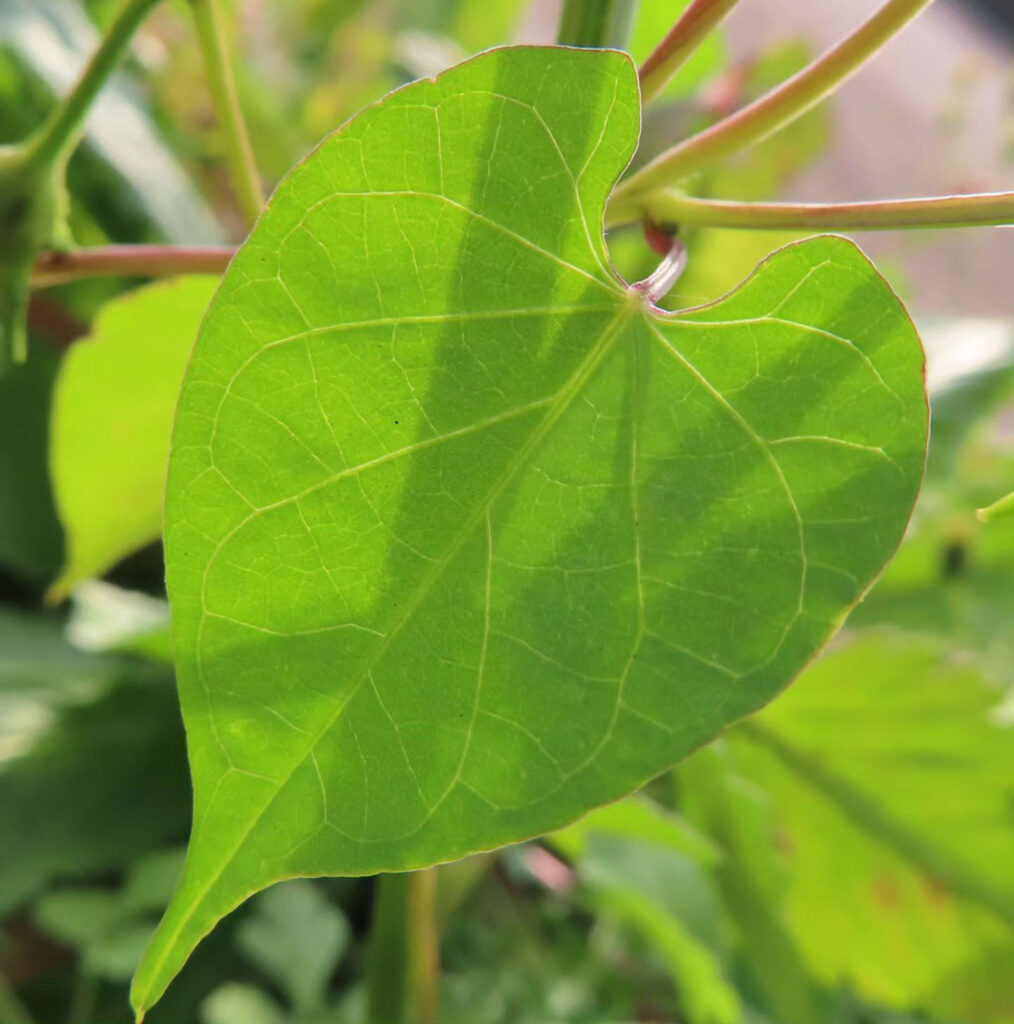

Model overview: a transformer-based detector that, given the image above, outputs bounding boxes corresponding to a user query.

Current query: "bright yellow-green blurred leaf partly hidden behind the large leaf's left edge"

[50,278,217,597]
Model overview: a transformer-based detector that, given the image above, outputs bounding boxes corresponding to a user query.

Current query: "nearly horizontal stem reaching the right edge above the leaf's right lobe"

[609,189,1014,231]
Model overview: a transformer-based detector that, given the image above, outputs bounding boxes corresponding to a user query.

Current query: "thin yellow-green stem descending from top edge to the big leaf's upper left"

[191,0,264,224]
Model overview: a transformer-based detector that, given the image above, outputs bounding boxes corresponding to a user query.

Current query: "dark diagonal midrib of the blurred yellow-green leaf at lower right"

[736,720,1014,925]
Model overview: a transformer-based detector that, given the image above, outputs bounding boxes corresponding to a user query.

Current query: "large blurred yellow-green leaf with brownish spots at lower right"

[732,634,1014,1016]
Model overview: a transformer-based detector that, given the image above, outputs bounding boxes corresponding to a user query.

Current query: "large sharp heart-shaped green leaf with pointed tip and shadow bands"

[133,48,926,1011]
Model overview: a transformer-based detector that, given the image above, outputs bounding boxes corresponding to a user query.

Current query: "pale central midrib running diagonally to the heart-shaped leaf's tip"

[144,307,634,998]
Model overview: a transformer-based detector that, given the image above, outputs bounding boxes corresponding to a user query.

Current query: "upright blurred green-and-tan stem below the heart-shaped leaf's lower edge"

[367,867,439,1024]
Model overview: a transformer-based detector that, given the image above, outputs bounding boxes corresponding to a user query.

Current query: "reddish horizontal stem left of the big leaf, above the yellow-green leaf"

[32,246,236,289]
